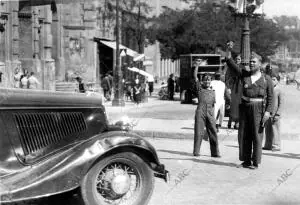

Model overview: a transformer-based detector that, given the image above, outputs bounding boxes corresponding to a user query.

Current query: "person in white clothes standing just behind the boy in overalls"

[211,72,226,132]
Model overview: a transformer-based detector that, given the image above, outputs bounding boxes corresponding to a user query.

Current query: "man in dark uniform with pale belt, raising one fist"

[226,42,273,169]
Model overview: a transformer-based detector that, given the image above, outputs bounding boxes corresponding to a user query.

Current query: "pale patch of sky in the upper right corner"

[263,0,300,18]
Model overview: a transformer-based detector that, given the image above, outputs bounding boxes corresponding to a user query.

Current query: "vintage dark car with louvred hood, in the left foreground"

[0,88,168,205]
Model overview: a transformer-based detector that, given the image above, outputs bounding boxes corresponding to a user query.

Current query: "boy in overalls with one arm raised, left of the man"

[193,59,221,157]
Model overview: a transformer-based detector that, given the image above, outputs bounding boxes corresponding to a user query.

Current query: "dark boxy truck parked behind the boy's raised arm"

[180,54,223,104]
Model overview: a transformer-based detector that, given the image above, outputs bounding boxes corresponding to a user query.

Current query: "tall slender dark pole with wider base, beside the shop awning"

[112,0,125,106]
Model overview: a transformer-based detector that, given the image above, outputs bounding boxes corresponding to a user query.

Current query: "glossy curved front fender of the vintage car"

[0,131,167,202]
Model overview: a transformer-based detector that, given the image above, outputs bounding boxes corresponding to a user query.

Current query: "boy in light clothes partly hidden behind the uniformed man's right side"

[263,73,284,151]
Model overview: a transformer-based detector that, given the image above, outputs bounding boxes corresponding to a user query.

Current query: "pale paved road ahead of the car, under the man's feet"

[150,139,300,205]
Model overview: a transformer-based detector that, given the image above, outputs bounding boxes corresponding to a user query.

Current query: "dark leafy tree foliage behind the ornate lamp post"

[148,1,286,58]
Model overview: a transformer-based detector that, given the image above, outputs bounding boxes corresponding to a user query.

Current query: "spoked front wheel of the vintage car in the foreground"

[81,152,154,205]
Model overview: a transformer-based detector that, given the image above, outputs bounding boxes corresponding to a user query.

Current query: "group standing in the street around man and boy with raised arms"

[193,41,283,169]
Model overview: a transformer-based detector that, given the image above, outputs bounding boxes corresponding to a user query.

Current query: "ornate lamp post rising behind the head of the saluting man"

[228,0,264,66]
